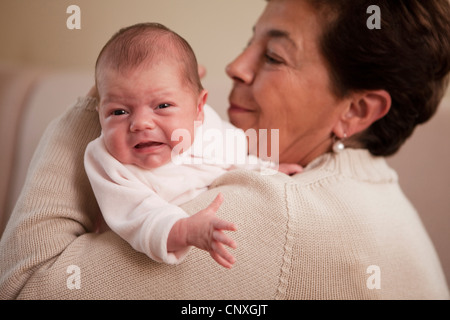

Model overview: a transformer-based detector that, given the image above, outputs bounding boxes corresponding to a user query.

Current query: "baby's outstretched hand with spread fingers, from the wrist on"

[186,193,237,268]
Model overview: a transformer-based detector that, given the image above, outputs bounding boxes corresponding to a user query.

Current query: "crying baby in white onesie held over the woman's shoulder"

[84,23,301,268]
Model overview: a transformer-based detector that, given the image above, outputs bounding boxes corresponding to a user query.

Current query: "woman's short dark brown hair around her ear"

[270,0,450,156]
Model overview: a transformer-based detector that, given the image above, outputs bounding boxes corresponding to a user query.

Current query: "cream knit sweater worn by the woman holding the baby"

[0,98,450,299]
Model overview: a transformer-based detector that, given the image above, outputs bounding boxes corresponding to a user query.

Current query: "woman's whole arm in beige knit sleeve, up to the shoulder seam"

[0,99,286,299]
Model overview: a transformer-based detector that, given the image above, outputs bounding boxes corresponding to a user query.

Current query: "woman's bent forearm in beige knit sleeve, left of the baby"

[0,98,100,298]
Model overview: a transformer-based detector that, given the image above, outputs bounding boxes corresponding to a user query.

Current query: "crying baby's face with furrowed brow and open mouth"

[98,63,207,169]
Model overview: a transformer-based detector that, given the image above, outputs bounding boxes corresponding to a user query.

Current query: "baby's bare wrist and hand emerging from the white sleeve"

[167,194,236,268]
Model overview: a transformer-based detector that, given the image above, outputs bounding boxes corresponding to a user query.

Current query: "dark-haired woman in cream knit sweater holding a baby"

[0,0,450,299]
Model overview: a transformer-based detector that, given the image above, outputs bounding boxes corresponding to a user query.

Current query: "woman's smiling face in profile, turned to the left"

[227,0,348,166]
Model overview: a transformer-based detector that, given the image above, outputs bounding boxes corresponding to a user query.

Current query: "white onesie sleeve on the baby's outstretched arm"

[84,136,189,264]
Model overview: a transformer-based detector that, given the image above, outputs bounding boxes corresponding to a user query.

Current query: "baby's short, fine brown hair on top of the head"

[95,22,203,93]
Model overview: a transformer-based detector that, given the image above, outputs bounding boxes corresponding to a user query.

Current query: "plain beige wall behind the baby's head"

[0,0,265,114]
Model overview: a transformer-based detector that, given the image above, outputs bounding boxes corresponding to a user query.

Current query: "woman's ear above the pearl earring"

[333,90,392,138]
